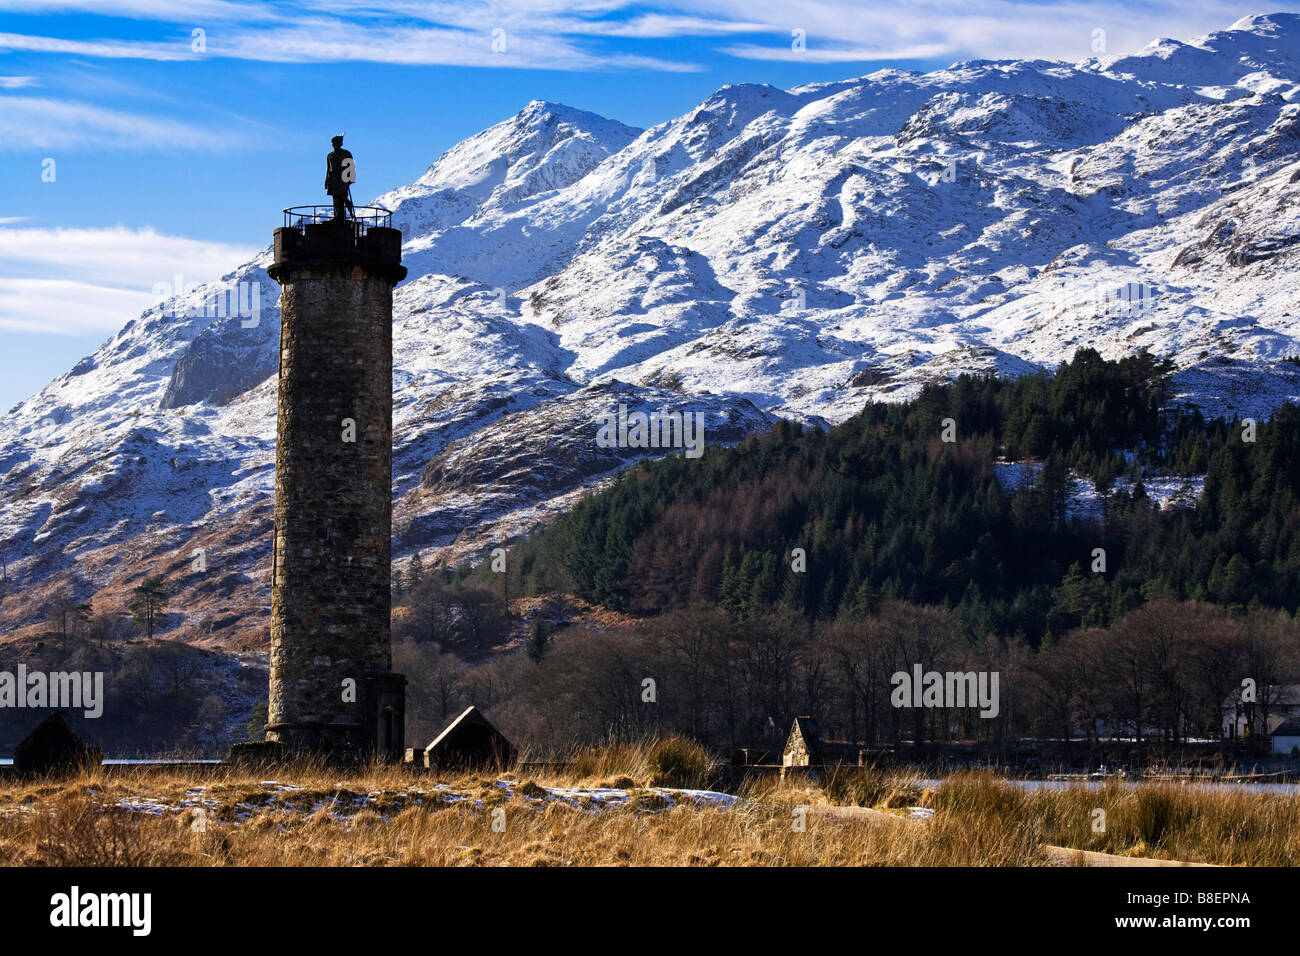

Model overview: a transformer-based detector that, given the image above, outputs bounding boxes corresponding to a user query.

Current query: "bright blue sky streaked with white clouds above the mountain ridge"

[0,0,1284,410]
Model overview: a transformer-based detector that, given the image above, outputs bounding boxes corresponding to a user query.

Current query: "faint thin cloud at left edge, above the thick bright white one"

[0,96,243,152]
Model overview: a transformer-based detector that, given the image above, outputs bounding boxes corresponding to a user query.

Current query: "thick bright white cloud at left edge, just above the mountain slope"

[0,226,257,334]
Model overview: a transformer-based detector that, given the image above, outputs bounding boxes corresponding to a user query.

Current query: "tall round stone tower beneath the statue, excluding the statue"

[267,207,406,760]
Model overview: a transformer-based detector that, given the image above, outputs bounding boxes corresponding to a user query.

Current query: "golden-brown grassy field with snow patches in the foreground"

[0,740,1300,866]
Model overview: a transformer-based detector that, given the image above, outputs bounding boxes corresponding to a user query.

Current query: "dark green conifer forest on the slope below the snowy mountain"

[501,349,1300,646]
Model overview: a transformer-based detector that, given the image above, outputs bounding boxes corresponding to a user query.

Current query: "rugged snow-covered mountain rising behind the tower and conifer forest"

[0,14,1300,646]
